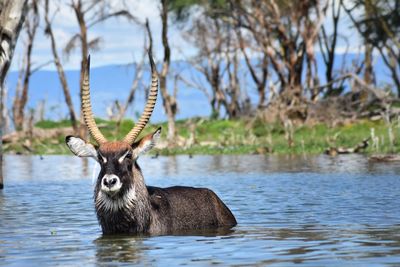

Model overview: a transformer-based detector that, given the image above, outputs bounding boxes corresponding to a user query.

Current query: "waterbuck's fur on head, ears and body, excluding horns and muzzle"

[66,137,236,235]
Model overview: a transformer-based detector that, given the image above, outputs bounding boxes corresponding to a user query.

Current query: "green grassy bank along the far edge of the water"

[4,119,400,155]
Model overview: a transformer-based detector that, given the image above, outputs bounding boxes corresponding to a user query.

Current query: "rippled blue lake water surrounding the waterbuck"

[0,155,400,266]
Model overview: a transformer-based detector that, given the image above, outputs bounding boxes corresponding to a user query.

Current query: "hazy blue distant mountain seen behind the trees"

[7,54,390,122]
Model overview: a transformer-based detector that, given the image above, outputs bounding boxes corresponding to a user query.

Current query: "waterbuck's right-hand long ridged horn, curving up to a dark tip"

[124,50,158,144]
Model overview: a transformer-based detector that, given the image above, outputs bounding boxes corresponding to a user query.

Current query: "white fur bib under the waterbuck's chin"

[96,186,137,212]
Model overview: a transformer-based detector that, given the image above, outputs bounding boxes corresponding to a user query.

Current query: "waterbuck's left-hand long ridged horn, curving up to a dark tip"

[81,55,107,144]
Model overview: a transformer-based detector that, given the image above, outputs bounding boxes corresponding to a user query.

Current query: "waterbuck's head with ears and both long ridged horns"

[66,53,161,199]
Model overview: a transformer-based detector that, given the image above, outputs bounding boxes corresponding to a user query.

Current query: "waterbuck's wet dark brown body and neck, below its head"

[95,162,236,235]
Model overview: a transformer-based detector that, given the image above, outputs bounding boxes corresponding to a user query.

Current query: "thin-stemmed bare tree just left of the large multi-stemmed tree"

[184,15,243,118]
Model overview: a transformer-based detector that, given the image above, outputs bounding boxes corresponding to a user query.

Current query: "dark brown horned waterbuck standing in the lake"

[65,52,236,235]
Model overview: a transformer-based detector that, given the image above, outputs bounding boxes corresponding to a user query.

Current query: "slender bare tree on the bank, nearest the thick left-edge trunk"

[12,0,39,131]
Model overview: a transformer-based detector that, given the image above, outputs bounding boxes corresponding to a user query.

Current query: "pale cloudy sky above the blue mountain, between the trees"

[11,0,360,71]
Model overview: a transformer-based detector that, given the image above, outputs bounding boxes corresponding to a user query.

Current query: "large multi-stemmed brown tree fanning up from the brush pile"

[232,0,326,105]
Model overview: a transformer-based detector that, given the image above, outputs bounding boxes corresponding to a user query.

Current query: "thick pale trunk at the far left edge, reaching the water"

[0,0,27,189]
